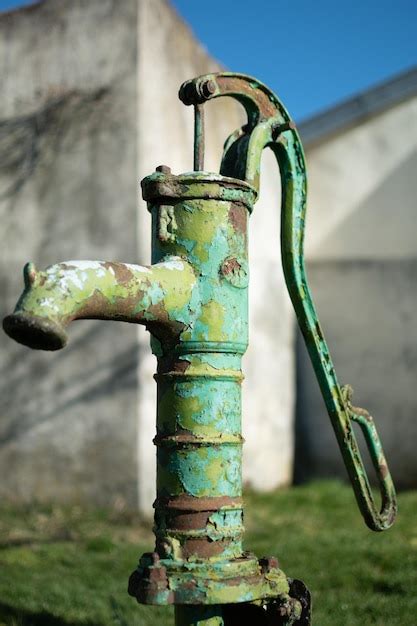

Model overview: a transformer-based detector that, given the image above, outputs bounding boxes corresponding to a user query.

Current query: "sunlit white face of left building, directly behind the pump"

[138,0,294,509]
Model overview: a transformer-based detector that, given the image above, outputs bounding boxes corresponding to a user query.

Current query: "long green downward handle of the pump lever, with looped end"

[271,131,397,531]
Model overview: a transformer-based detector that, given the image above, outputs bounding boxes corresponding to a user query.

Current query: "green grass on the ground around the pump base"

[0,482,417,626]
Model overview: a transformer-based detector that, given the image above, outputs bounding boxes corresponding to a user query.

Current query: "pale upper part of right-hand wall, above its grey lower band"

[306,98,417,260]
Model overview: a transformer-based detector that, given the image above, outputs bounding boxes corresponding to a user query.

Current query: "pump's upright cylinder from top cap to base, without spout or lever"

[143,168,254,562]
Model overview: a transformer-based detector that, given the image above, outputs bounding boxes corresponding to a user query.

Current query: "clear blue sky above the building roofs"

[0,0,417,120]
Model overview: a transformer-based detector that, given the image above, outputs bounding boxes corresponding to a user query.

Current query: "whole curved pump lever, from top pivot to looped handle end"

[179,73,397,531]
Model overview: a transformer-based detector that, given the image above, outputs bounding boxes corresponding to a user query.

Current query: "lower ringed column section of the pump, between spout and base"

[155,344,244,565]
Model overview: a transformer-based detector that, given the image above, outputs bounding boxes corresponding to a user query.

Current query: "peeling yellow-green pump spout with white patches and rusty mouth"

[3,257,196,350]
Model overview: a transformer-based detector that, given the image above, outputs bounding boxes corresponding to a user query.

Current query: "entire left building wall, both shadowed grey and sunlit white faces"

[0,0,294,512]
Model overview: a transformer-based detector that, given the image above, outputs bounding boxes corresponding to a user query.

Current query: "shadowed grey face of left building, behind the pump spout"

[0,0,138,504]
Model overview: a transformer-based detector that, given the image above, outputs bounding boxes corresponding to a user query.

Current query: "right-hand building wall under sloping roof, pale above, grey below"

[297,98,417,486]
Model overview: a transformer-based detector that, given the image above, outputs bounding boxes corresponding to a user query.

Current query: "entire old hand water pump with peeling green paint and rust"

[4,73,396,626]
